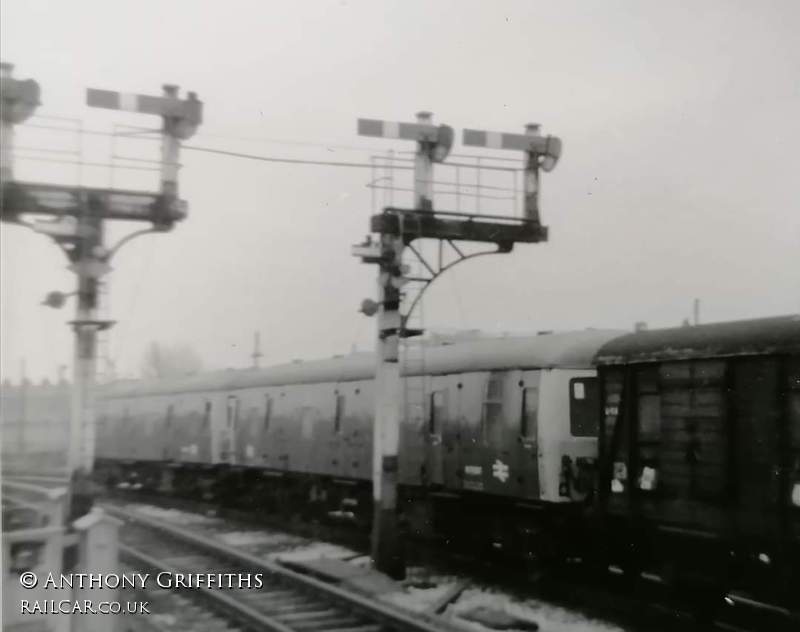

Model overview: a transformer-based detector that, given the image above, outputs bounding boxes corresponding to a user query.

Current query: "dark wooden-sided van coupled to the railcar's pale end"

[597,315,800,607]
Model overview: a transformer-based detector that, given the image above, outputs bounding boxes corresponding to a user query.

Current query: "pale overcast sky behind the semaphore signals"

[0,0,800,381]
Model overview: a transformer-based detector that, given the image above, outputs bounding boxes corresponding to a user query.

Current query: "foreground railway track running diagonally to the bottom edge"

[106,507,455,632]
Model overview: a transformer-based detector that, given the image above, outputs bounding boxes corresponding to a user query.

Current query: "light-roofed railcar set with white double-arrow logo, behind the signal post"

[97,330,620,553]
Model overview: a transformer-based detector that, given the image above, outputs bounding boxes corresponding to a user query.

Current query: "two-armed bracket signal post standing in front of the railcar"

[353,112,561,578]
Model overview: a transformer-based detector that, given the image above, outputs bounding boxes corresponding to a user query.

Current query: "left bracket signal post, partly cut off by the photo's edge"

[0,68,202,516]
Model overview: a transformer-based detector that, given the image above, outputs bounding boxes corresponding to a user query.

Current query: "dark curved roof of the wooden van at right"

[596,314,800,365]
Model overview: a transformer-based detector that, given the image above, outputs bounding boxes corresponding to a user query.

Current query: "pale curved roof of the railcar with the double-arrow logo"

[102,329,623,397]
